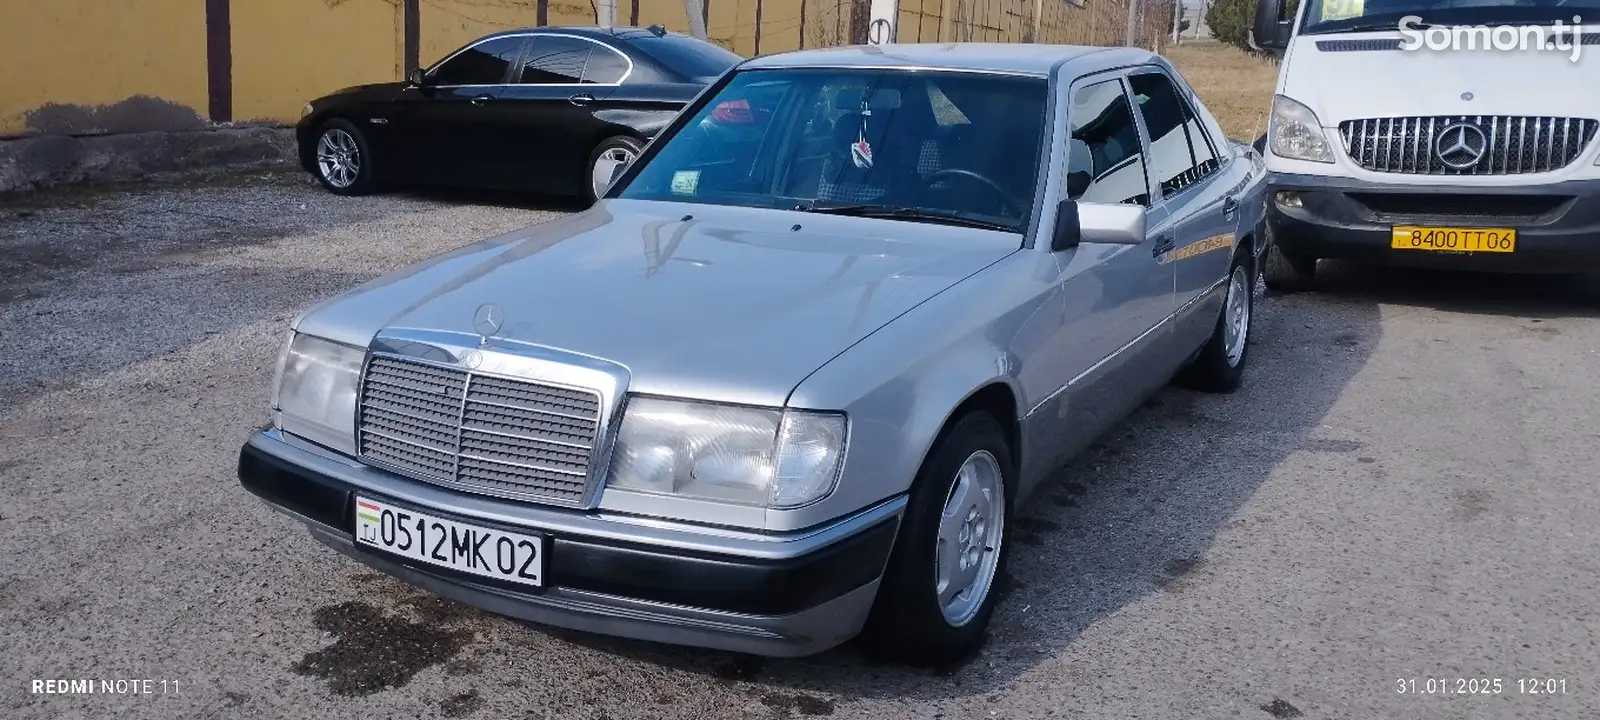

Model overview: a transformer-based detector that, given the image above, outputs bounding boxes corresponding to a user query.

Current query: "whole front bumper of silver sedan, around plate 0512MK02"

[238,430,906,658]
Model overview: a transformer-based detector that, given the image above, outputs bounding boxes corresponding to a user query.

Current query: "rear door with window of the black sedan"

[493,34,617,194]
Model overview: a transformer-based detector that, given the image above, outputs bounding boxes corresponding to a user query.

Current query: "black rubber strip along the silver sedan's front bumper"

[238,445,899,616]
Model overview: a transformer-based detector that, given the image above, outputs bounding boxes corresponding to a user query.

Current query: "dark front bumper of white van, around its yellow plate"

[1267,174,1600,272]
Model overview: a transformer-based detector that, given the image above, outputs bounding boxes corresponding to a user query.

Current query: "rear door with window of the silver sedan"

[1128,67,1238,347]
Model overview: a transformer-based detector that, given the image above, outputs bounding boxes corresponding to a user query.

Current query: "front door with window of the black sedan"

[392,35,523,186]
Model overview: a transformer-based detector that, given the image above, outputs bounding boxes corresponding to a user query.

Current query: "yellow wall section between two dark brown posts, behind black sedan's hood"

[232,0,405,120]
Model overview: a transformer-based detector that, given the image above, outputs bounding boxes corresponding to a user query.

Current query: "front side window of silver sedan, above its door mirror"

[1067,80,1150,206]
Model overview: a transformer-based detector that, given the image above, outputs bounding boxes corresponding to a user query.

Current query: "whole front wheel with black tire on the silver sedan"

[861,411,1016,667]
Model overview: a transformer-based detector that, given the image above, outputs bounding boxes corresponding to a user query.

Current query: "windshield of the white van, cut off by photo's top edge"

[1290,0,1600,35]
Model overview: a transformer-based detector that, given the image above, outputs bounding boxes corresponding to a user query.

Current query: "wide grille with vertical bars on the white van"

[1339,115,1600,174]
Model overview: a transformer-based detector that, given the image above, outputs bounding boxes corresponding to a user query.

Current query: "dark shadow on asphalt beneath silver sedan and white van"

[486,264,1595,714]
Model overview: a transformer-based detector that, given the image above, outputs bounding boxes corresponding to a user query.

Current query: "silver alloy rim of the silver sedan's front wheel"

[934,450,1005,627]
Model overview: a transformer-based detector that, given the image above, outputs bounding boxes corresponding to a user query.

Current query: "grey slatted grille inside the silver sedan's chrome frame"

[357,355,600,506]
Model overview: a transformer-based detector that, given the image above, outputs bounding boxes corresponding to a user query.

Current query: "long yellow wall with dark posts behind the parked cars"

[0,0,1171,138]
